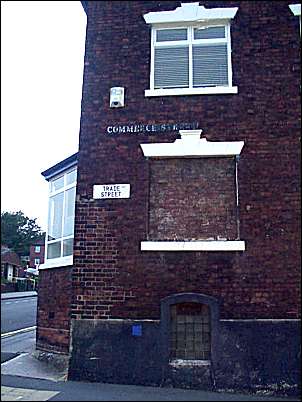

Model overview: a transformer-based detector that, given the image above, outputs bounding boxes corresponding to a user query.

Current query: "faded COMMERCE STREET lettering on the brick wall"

[106,122,198,134]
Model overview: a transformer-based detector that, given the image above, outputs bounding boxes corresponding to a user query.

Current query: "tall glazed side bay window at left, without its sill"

[46,169,77,259]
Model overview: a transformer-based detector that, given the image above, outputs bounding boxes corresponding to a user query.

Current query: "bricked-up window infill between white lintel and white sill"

[148,158,237,240]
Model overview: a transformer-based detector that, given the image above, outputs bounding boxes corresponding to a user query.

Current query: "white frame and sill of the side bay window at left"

[40,166,77,269]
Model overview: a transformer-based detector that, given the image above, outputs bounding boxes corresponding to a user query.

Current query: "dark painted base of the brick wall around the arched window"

[68,320,300,395]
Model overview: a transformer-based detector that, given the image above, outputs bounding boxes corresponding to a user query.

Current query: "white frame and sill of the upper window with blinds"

[145,20,238,96]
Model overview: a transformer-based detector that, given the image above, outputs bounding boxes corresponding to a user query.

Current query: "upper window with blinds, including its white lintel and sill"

[144,3,237,96]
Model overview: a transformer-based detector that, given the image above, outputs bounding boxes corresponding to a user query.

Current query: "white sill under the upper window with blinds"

[145,87,238,97]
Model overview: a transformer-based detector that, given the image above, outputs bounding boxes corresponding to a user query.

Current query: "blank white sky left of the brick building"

[1,1,86,231]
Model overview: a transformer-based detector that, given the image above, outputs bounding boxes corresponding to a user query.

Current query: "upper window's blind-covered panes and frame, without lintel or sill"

[151,24,232,89]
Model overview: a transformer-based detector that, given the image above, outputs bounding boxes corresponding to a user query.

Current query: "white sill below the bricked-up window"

[141,240,245,251]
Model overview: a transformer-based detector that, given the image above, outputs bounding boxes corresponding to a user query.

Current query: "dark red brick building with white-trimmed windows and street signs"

[37,1,301,396]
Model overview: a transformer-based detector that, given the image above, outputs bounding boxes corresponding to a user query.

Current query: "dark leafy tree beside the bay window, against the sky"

[1,211,44,256]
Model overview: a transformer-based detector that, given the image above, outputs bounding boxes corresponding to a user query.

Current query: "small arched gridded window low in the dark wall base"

[170,303,211,360]
